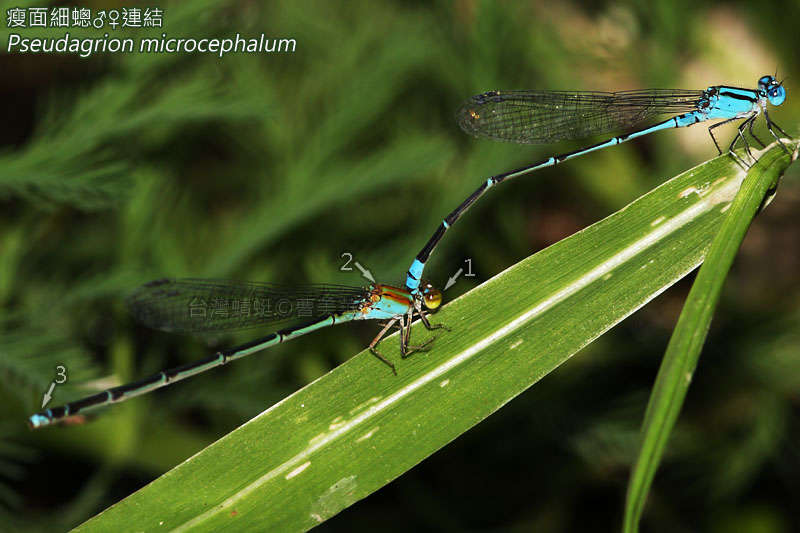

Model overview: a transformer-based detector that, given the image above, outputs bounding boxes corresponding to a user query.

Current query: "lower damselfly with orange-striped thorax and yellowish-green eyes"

[28,279,443,429]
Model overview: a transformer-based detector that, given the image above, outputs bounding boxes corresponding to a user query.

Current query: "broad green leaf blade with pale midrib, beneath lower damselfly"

[73,140,792,531]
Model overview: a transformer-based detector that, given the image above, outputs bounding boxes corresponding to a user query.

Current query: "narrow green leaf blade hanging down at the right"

[623,139,796,532]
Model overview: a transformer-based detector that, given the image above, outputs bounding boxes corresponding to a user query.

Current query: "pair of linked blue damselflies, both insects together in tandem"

[29,76,788,428]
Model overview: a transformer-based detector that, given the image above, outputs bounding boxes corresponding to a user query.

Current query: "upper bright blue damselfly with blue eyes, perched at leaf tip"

[406,76,788,295]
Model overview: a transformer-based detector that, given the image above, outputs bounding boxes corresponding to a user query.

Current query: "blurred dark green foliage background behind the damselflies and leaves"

[0,0,800,532]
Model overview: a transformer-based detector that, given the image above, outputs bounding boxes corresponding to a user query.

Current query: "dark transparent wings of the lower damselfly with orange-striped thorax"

[127,278,369,333]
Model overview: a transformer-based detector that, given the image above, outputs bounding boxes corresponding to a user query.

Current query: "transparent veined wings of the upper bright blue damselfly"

[456,89,703,144]
